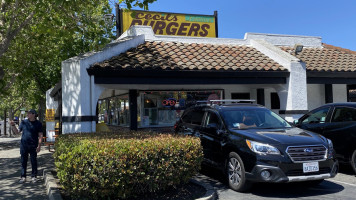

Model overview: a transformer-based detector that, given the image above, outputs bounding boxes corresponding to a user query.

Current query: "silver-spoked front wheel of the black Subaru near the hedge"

[226,152,251,192]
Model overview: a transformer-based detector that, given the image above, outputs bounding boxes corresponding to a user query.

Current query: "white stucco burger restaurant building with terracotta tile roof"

[47,26,356,133]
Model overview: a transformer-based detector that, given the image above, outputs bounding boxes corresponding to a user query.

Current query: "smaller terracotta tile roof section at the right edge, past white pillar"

[281,44,356,72]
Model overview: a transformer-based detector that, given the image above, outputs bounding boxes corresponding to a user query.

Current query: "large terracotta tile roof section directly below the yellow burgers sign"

[90,42,287,71]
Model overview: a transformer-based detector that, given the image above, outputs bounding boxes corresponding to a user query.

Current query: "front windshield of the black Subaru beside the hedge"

[222,108,291,129]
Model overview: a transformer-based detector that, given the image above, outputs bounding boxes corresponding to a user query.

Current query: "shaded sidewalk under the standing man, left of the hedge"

[0,136,54,200]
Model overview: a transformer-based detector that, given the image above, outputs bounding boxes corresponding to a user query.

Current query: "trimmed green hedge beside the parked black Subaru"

[54,132,203,199]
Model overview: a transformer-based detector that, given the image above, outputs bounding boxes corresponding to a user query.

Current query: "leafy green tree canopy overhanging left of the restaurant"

[0,0,155,128]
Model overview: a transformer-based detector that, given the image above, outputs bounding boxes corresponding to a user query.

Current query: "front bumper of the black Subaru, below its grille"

[246,160,339,183]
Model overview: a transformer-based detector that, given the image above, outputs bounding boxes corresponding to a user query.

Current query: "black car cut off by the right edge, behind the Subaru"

[294,103,356,173]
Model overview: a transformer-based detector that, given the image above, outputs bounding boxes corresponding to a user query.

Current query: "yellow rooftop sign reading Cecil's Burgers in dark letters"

[121,10,217,37]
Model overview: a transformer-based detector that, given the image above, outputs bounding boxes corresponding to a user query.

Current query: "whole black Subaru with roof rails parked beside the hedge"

[175,101,338,191]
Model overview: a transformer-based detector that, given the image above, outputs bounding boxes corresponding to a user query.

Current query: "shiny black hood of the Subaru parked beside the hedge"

[232,127,326,145]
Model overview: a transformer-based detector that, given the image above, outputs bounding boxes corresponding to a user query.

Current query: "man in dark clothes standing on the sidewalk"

[10,109,43,183]
